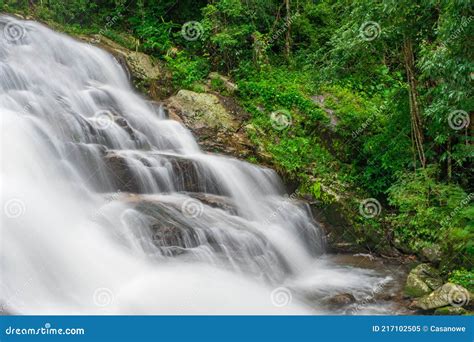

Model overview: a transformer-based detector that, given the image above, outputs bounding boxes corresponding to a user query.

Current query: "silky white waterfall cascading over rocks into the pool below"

[0,16,408,314]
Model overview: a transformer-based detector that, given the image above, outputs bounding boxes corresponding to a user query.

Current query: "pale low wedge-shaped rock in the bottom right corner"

[412,283,470,310]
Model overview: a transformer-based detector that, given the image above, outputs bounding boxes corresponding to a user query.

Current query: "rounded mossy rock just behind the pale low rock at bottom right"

[405,264,443,297]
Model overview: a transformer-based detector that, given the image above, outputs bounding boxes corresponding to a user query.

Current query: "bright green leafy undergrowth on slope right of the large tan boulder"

[238,69,332,176]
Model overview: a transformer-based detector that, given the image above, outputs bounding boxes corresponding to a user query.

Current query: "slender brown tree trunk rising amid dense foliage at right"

[403,38,426,168]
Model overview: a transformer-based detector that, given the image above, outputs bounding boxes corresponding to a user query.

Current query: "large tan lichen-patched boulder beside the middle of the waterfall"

[166,90,256,158]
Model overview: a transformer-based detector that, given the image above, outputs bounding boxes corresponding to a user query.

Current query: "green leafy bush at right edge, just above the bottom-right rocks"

[388,167,474,265]
